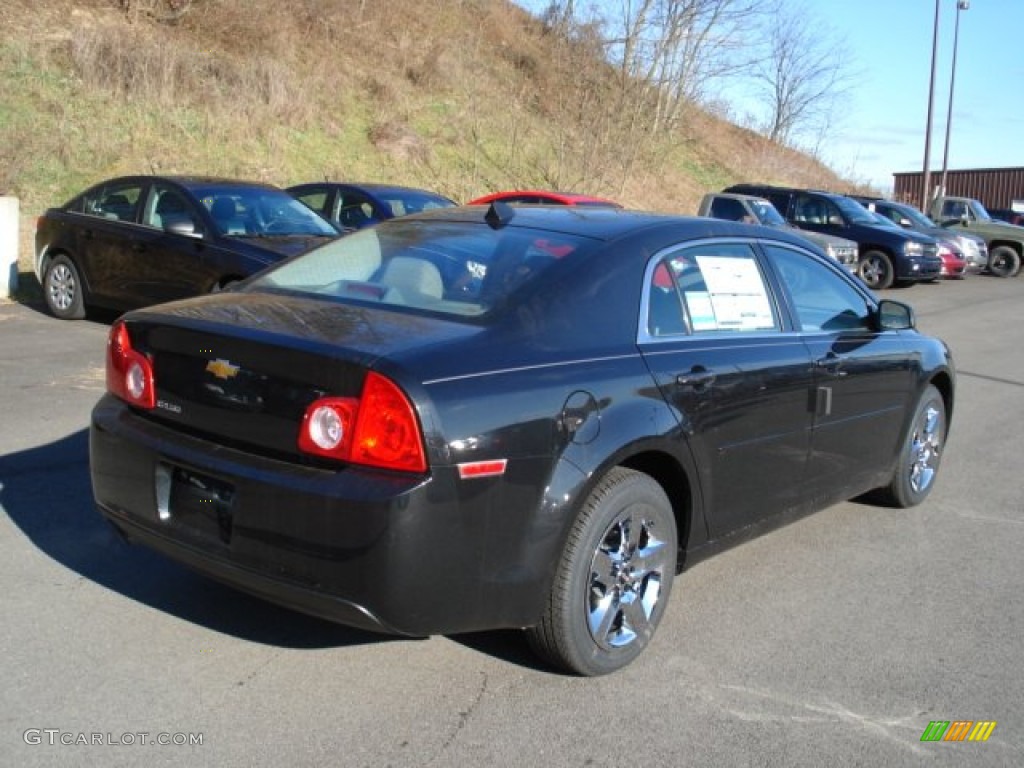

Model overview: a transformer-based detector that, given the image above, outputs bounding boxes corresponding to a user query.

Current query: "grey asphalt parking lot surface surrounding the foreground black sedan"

[0,276,1024,768]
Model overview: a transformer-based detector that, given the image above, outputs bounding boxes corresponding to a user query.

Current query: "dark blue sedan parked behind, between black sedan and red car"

[288,181,455,231]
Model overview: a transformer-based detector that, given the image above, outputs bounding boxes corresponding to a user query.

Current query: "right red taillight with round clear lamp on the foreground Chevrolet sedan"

[299,373,427,472]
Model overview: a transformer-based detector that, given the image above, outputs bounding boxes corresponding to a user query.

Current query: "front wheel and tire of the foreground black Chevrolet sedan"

[879,385,946,509]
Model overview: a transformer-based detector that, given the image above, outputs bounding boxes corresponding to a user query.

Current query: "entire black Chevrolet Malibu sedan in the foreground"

[90,203,955,675]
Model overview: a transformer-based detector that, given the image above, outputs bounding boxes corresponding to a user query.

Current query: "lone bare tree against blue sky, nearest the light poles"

[753,5,852,143]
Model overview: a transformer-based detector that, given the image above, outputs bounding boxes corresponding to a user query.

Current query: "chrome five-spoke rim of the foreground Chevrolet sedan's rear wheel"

[586,512,674,650]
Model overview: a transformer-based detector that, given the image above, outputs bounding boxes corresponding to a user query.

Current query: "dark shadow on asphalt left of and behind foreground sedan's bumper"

[0,429,407,648]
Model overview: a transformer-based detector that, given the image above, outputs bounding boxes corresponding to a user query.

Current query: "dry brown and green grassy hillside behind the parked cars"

[0,0,864,282]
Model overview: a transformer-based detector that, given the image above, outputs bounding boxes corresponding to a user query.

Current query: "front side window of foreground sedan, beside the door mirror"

[765,245,870,331]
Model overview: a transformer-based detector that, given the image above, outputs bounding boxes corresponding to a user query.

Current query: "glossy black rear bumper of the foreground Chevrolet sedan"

[89,395,536,636]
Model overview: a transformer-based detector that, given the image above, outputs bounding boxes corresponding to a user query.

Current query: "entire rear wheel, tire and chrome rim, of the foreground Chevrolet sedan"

[527,467,678,676]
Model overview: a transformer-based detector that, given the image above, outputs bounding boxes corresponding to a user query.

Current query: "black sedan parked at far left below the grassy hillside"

[35,176,340,319]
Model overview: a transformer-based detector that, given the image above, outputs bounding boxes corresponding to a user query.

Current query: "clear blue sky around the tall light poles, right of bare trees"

[519,0,1024,191]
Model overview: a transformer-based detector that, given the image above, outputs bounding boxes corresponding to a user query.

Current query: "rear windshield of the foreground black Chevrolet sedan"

[250,219,596,316]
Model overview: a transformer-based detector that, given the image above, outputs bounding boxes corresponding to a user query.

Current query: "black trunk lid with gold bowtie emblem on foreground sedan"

[126,293,472,462]
